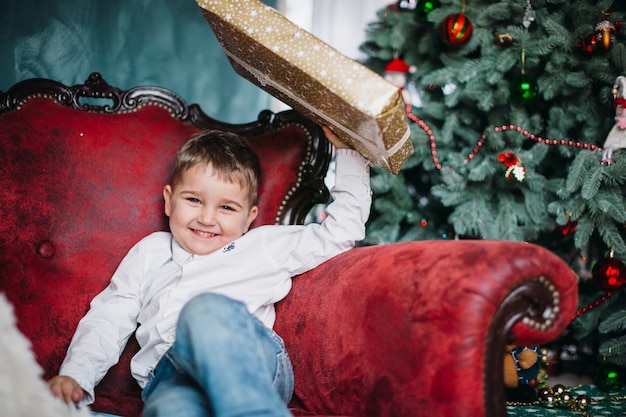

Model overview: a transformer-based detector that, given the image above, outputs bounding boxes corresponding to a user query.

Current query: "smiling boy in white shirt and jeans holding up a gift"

[49,127,371,417]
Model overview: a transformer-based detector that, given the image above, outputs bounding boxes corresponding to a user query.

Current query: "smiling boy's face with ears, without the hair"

[163,164,258,255]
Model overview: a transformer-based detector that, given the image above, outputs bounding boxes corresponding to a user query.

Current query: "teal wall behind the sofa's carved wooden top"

[0,0,276,123]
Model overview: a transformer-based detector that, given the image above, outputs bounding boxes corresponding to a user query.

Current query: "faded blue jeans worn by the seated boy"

[142,294,293,417]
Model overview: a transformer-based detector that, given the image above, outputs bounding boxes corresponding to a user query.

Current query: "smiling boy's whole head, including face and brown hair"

[163,133,261,255]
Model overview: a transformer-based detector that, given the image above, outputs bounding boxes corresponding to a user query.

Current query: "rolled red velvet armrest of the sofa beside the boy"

[276,237,577,417]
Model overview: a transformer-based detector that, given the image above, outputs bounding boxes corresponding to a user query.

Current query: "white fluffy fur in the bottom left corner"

[0,293,92,417]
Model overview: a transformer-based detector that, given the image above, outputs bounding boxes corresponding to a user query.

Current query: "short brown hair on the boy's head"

[171,130,261,206]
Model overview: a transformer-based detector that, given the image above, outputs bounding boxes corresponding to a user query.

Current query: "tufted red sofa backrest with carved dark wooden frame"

[0,73,330,415]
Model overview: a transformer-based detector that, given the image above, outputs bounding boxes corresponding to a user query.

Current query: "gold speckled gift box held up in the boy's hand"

[196,0,413,174]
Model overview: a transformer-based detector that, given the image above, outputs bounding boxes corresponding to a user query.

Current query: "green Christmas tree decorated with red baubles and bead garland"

[361,0,626,376]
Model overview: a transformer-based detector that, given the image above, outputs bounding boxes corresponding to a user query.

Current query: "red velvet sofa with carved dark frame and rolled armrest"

[0,73,577,417]
